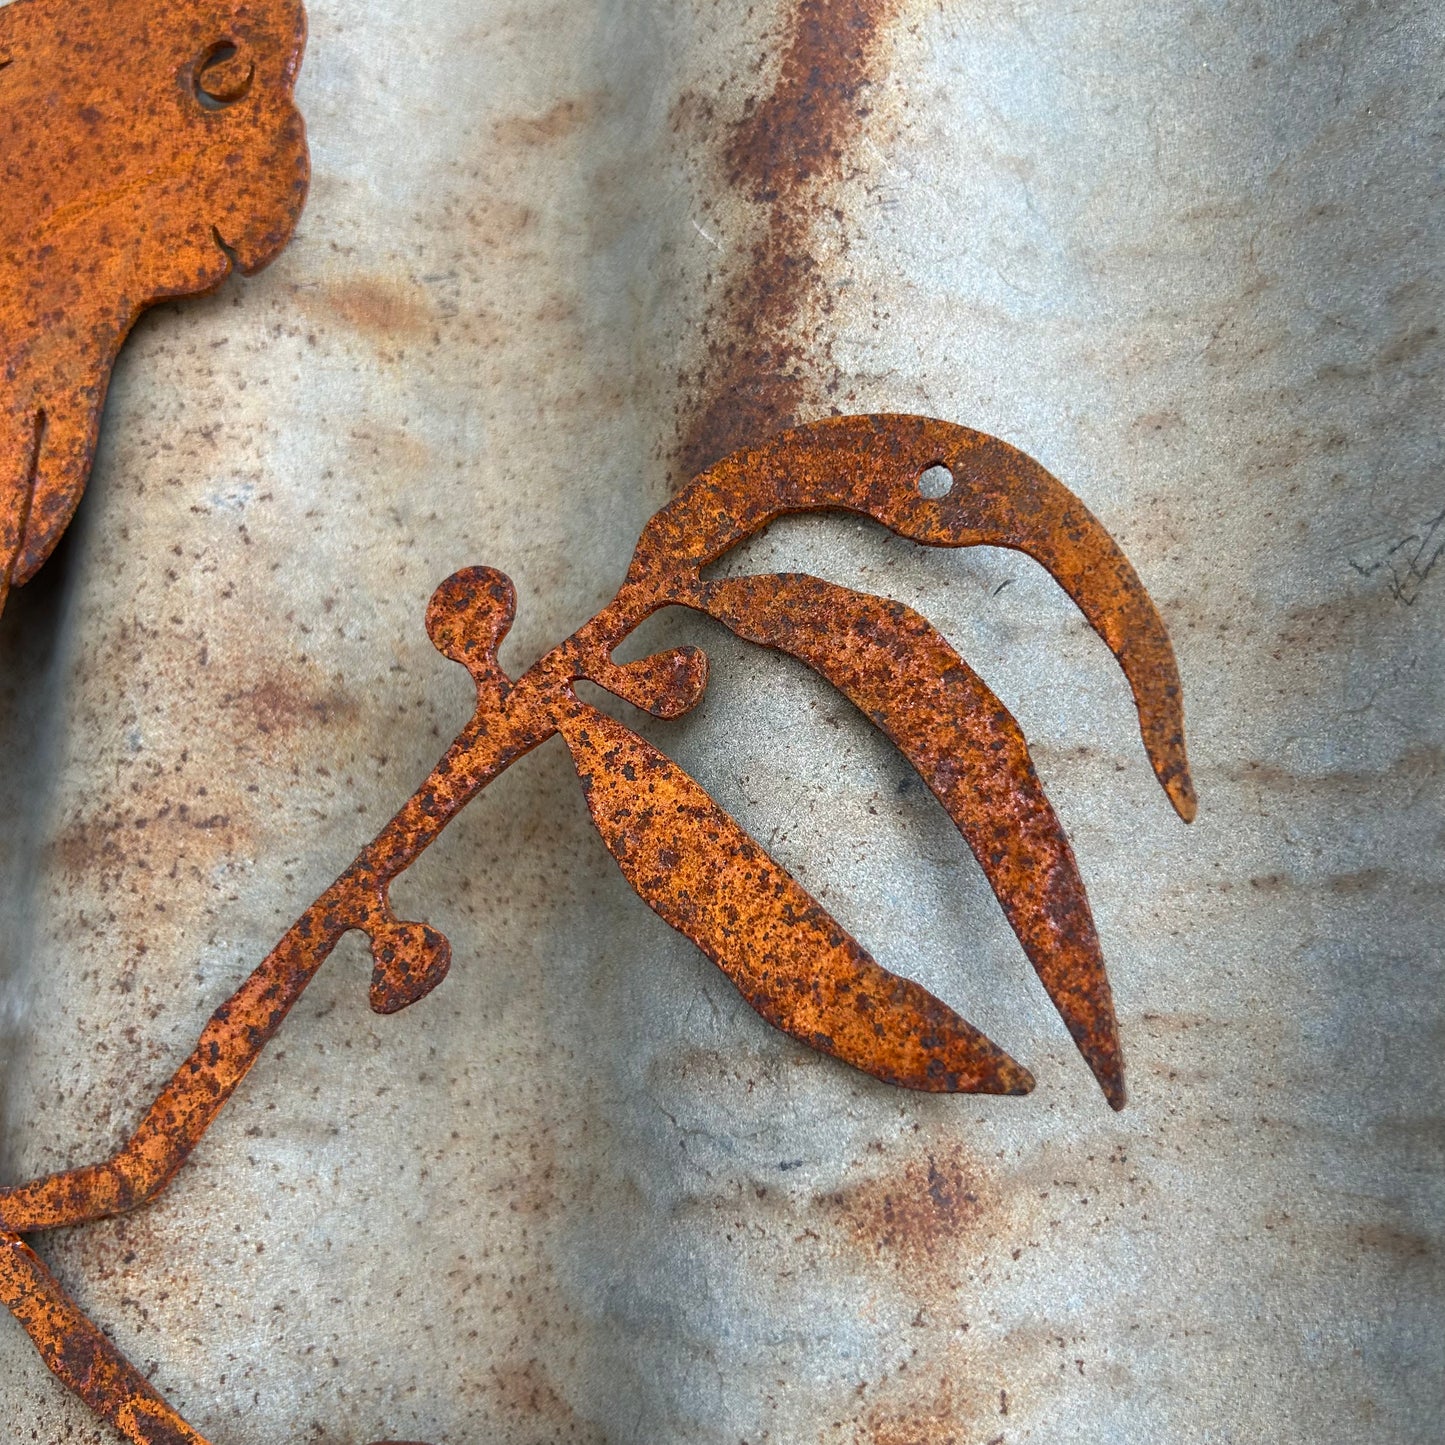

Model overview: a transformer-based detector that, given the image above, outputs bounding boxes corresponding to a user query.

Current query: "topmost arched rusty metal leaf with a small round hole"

[630,416,1196,822]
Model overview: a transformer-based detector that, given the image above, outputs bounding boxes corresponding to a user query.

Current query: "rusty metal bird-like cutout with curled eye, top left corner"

[0,0,311,608]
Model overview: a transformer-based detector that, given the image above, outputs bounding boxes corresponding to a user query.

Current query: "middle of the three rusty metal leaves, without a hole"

[702,574,1124,1108]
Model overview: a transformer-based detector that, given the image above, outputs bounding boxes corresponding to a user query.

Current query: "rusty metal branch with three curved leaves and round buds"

[0,416,1195,1445]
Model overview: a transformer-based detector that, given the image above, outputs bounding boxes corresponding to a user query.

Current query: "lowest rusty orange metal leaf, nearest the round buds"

[558,704,1033,1094]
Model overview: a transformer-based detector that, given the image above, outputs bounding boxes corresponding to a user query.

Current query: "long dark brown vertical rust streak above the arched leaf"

[676,0,900,478]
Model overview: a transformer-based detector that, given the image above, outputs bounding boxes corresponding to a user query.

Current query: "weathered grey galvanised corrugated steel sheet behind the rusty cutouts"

[0,0,1445,1445]
